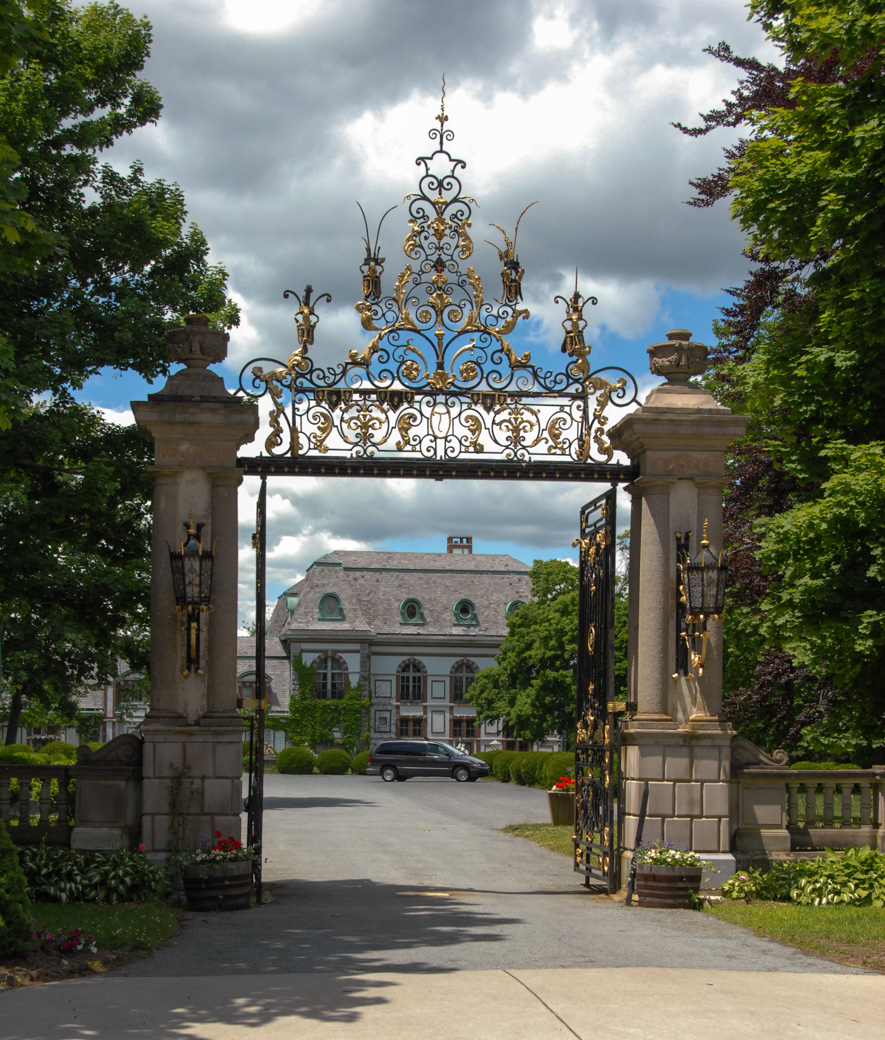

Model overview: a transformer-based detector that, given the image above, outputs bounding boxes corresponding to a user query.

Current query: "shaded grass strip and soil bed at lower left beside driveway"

[0,903,181,988]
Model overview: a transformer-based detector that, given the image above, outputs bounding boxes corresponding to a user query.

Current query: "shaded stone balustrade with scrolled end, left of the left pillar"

[0,733,142,850]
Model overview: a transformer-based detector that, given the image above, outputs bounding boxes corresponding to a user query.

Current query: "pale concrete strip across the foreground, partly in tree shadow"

[0,968,885,1040]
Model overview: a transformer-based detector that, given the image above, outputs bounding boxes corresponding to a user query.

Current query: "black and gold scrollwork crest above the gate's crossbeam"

[239,101,637,465]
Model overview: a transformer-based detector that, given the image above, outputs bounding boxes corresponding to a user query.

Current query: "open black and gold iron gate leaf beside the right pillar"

[574,488,621,892]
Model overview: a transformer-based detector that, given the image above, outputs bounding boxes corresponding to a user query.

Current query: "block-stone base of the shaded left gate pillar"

[141,720,242,854]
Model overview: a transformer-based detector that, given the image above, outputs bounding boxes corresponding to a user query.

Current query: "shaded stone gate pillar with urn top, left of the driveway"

[132,314,258,854]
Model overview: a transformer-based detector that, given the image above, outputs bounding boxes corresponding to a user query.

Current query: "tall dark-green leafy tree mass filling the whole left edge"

[0,0,237,740]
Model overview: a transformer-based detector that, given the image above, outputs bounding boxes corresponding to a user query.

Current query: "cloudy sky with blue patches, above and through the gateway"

[75,0,773,620]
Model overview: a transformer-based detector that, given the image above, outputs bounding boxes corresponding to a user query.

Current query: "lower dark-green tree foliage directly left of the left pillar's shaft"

[0,402,150,744]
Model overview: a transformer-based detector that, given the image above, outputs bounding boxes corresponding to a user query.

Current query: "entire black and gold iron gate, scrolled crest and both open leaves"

[238,97,637,892]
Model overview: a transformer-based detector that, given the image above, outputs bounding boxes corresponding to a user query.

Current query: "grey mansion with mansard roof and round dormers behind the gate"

[238,536,530,752]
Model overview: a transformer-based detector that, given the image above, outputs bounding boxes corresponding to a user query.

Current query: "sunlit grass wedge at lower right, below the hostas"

[706,900,885,972]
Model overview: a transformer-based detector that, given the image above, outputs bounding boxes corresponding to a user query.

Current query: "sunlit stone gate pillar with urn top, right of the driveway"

[609,330,748,884]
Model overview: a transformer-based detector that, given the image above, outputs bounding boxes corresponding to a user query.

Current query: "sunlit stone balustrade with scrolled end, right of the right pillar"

[730,738,885,865]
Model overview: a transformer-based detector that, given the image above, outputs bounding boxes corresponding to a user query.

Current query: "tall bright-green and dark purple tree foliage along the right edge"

[682,0,885,759]
